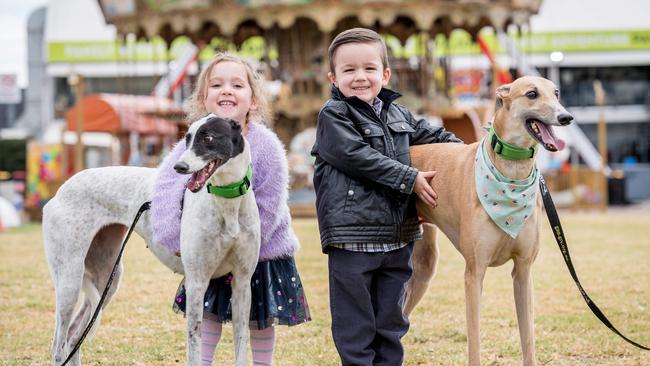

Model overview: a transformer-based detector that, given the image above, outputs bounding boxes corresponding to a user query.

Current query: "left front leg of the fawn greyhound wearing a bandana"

[465,258,487,366]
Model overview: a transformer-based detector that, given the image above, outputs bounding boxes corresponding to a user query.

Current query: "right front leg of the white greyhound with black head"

[232,268,253,366]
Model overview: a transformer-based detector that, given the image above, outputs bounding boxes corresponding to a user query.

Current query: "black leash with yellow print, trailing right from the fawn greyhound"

[539,174,650,351]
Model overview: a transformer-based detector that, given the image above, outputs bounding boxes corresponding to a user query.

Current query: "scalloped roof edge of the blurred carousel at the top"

[99,0,542,43]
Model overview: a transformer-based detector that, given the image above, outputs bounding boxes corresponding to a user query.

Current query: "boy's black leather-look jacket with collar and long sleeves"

[311,86,462,252]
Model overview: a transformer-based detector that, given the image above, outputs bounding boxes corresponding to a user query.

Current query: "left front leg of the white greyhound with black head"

[185,270,210,366]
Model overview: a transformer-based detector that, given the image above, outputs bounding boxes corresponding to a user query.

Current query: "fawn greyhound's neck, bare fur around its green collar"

[487,122,536,180]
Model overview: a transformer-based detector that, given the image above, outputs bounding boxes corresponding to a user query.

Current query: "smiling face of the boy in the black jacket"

[327,43,390,105]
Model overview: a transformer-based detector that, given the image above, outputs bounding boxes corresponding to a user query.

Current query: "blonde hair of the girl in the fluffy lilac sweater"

[185,52,269,123]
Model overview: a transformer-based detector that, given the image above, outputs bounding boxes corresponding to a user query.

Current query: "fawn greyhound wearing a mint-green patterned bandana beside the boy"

[404,77,573,366]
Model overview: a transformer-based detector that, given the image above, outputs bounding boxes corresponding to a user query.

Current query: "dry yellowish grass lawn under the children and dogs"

[0,211,650,366]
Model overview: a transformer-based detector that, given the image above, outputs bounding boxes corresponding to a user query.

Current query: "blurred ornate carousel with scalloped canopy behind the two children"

[99,0,541,143]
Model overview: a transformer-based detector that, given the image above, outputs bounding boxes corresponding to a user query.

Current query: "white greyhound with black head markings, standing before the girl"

[43,115,260,366]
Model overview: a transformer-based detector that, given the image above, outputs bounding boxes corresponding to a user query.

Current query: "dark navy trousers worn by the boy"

[328,243,413,366]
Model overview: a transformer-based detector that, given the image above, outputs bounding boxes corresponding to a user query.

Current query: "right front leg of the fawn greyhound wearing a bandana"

[512,258,536,366]
